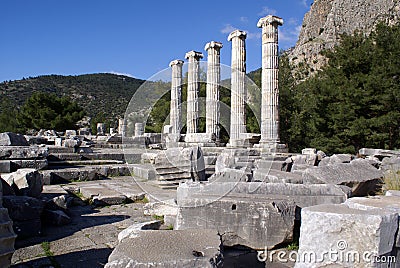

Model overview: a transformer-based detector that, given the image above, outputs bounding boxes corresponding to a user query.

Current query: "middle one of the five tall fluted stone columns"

[204,41,222,140]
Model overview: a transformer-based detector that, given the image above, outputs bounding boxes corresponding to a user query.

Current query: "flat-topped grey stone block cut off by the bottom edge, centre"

[105,230,223,268]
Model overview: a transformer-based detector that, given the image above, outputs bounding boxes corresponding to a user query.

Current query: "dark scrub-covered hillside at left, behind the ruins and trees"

[0,74,145,120]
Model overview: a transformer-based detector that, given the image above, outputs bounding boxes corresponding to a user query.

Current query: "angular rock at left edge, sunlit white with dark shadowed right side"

[2,168,44,197]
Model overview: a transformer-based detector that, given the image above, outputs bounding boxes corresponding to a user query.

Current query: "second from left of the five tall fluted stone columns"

[185,50,203,134]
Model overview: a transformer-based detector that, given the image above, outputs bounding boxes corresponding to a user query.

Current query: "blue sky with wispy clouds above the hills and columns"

[0,0,313,81]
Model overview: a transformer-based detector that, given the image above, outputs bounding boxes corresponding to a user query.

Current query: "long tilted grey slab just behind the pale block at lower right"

[303,159,383,196]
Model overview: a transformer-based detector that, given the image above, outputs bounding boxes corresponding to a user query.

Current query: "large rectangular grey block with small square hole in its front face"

[175,197,296,249]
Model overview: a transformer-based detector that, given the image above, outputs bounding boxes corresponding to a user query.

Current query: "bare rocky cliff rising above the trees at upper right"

[290,0,400,71]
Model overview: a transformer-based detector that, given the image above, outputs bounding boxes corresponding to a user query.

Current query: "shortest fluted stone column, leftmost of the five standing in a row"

[169,60,183,141]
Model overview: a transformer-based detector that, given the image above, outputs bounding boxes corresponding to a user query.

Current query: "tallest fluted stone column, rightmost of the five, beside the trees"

[257,15,283,144]
